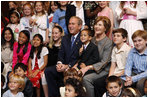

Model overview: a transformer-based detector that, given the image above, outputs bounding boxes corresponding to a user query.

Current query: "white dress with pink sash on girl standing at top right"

[115,1,147,47]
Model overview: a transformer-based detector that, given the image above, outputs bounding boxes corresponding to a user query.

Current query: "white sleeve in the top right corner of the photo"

[136,1,147,19]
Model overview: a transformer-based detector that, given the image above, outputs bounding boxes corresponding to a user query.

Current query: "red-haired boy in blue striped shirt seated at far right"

[124,30,147,93]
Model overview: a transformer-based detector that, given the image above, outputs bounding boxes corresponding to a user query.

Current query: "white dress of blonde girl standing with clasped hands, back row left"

[31,15,47,41]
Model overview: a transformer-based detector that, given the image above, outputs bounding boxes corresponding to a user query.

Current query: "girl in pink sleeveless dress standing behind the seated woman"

[98,1,113,39]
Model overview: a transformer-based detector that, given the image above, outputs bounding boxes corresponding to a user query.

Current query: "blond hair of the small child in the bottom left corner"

[9,74,25,92]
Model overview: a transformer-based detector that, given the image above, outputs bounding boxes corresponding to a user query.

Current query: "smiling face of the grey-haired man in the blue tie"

[68,17,82,35]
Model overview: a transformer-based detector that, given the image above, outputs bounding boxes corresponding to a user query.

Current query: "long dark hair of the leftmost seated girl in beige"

[1,27,15,50]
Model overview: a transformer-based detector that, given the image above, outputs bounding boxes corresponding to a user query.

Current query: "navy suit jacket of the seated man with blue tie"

[58,33,82,67]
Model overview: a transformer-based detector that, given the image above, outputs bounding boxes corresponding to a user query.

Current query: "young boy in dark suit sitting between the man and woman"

[75,29,99,73]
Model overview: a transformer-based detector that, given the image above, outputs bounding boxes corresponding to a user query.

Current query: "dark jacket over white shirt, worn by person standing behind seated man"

[65,3,90,27]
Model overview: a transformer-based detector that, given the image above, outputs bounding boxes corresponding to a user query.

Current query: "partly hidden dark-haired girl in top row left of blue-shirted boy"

[47,1,58,36]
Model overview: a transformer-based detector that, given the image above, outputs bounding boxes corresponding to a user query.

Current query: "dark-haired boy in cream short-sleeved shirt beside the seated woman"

[109,28,131,77]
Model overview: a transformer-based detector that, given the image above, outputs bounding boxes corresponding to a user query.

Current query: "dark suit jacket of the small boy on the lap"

[78,42,99,68]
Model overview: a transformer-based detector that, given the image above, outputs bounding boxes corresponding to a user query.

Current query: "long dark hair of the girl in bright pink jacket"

[17,30,30,54]
